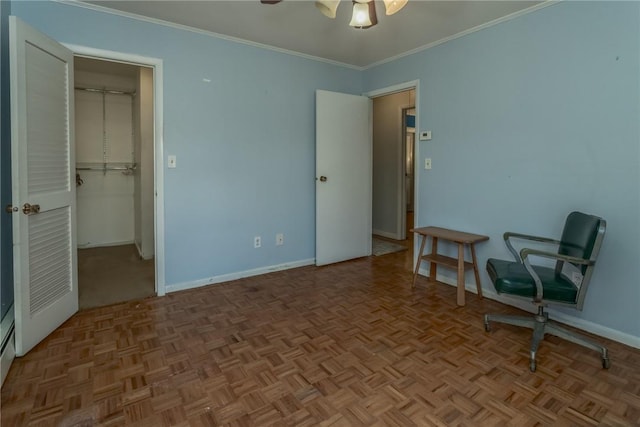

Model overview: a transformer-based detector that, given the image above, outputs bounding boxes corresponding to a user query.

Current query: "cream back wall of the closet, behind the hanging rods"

[75,70,136,248]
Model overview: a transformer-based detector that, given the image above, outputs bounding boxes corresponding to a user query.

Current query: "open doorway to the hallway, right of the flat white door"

[372,88,415,254]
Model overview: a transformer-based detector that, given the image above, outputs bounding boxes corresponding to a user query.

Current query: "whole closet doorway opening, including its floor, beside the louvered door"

[74,56,156,309]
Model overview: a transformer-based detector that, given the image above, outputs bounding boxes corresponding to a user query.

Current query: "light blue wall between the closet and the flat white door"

[13,2,362,286]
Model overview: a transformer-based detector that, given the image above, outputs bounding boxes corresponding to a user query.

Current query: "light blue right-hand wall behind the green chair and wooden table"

[364,2,640,337]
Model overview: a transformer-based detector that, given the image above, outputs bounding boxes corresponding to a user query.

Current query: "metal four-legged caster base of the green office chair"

[484,306,611,372]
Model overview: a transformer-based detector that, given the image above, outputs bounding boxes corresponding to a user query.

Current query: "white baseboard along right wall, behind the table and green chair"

[420,268,640,349]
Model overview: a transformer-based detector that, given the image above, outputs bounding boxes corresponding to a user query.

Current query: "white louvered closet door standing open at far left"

[10,17,78,356]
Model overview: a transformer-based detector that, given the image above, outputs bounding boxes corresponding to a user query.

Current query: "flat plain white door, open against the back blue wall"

[316,90,372,265]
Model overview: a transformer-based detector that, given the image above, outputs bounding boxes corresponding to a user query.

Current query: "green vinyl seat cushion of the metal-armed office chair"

[487,258,578,303]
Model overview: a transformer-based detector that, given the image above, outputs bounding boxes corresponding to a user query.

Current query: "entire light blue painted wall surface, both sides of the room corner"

[12,2,640,337]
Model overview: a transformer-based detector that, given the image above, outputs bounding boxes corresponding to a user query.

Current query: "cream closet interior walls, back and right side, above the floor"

[74,58,154,259]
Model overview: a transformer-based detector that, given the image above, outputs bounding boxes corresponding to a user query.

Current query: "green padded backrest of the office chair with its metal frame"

[556,212,607,310]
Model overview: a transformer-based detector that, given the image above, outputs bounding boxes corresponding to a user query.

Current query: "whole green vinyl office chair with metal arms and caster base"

[484,212,611,372]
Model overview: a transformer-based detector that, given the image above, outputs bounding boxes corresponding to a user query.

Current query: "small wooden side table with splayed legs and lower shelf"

[411,227,489,306]
